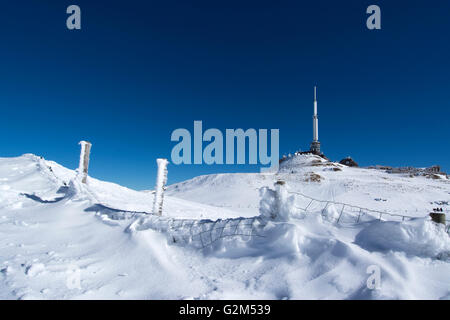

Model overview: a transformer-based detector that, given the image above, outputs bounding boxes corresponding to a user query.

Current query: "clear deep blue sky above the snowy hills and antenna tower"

[0,0,450,189]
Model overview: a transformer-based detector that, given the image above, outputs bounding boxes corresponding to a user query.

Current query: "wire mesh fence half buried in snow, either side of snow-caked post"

[91,185,450,249]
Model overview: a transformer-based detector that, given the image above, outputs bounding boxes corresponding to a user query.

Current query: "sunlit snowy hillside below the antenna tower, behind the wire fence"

[168,155,450,217]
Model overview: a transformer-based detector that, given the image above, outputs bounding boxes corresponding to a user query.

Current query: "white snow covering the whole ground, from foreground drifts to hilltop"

[0,154,450,299]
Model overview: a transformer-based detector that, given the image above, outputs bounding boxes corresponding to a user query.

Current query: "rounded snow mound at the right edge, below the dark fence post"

[355,218,450,257]
